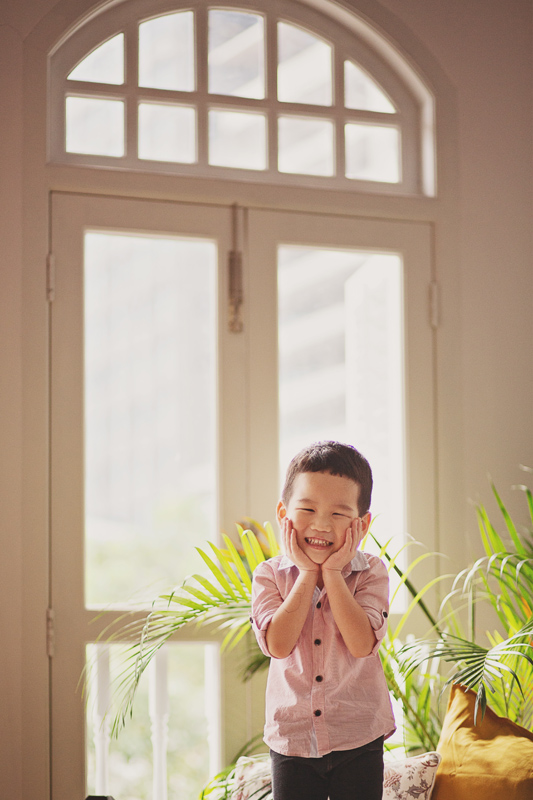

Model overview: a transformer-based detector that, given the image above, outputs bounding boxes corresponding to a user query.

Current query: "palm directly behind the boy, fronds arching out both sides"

[104,520,443,751]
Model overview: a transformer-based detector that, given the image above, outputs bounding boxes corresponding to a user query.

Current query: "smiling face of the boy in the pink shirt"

[277,472,370,564]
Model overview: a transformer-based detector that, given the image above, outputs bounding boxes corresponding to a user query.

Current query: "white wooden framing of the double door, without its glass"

[46,192,436,800]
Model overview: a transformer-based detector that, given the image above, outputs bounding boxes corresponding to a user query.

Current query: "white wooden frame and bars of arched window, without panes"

[48,0,435,196]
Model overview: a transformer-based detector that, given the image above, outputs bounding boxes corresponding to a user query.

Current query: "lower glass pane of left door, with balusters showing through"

[86,643,216,800]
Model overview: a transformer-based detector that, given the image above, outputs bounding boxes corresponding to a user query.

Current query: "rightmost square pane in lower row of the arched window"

[344,122,400,183]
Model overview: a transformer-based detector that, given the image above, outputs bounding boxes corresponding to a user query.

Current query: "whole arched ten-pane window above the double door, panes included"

[50,0,428,193]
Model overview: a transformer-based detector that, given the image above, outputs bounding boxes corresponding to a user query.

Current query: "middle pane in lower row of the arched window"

[209,110,266,169]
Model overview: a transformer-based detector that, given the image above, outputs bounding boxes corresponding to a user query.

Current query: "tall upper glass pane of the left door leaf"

[85,232,217,606]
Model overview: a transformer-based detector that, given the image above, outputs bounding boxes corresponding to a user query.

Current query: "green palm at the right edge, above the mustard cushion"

[398,470,533,730]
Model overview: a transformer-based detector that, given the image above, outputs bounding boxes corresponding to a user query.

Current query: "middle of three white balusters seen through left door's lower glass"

[149,647,170,800]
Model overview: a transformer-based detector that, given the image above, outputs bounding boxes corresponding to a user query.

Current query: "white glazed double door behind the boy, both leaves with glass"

[50,194,435,800]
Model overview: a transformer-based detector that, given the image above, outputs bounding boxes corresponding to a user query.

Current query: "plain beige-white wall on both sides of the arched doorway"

[0,0,533,800]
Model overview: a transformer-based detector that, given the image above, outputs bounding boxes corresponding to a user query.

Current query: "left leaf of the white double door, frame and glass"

[51,194,241,800]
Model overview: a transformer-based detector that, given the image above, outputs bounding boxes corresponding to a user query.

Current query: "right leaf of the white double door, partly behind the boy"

[248,210,435,560]
